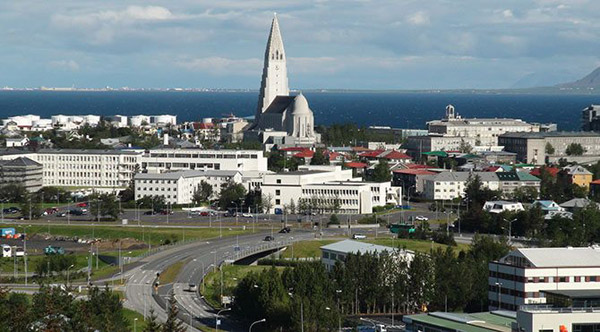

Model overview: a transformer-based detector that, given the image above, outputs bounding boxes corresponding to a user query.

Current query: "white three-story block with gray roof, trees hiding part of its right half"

[134,170,242,204]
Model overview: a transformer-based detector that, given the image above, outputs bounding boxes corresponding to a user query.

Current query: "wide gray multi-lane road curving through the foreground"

[124,230,324,331]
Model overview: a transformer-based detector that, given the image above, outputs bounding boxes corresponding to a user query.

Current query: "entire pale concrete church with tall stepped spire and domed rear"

[244,16,321,148]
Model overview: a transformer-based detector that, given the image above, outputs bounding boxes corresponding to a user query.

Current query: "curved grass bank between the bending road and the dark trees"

[200,265,283,308]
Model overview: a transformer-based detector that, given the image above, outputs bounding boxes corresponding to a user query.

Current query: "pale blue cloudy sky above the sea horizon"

[0,0,600,90]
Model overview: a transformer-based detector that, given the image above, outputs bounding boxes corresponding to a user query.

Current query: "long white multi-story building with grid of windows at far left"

[0,149,142,190]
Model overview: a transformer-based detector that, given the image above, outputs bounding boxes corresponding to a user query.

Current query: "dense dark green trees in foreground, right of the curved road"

[233,235,510,331]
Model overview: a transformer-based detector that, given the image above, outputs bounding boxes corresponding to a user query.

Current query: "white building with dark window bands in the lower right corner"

[488,246,600,312]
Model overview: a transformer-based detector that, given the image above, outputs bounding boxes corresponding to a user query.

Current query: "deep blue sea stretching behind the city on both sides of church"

[0,90,600,130]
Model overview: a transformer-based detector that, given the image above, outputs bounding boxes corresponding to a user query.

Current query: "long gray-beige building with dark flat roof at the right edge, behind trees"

[498,131,600,165]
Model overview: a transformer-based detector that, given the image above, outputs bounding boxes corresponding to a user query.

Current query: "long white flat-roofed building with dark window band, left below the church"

[141,149,267,173]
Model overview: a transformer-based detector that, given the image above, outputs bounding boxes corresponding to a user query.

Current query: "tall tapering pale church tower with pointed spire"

[254,14,290,125]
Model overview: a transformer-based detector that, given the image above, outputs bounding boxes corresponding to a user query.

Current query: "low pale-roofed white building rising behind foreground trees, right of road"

[321,240,415,271]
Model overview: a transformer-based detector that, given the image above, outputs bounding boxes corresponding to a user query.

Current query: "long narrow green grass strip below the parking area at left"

[2,221,251,245]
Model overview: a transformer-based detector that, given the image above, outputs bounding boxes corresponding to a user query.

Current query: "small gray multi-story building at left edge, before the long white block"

[0,157,43,192]
